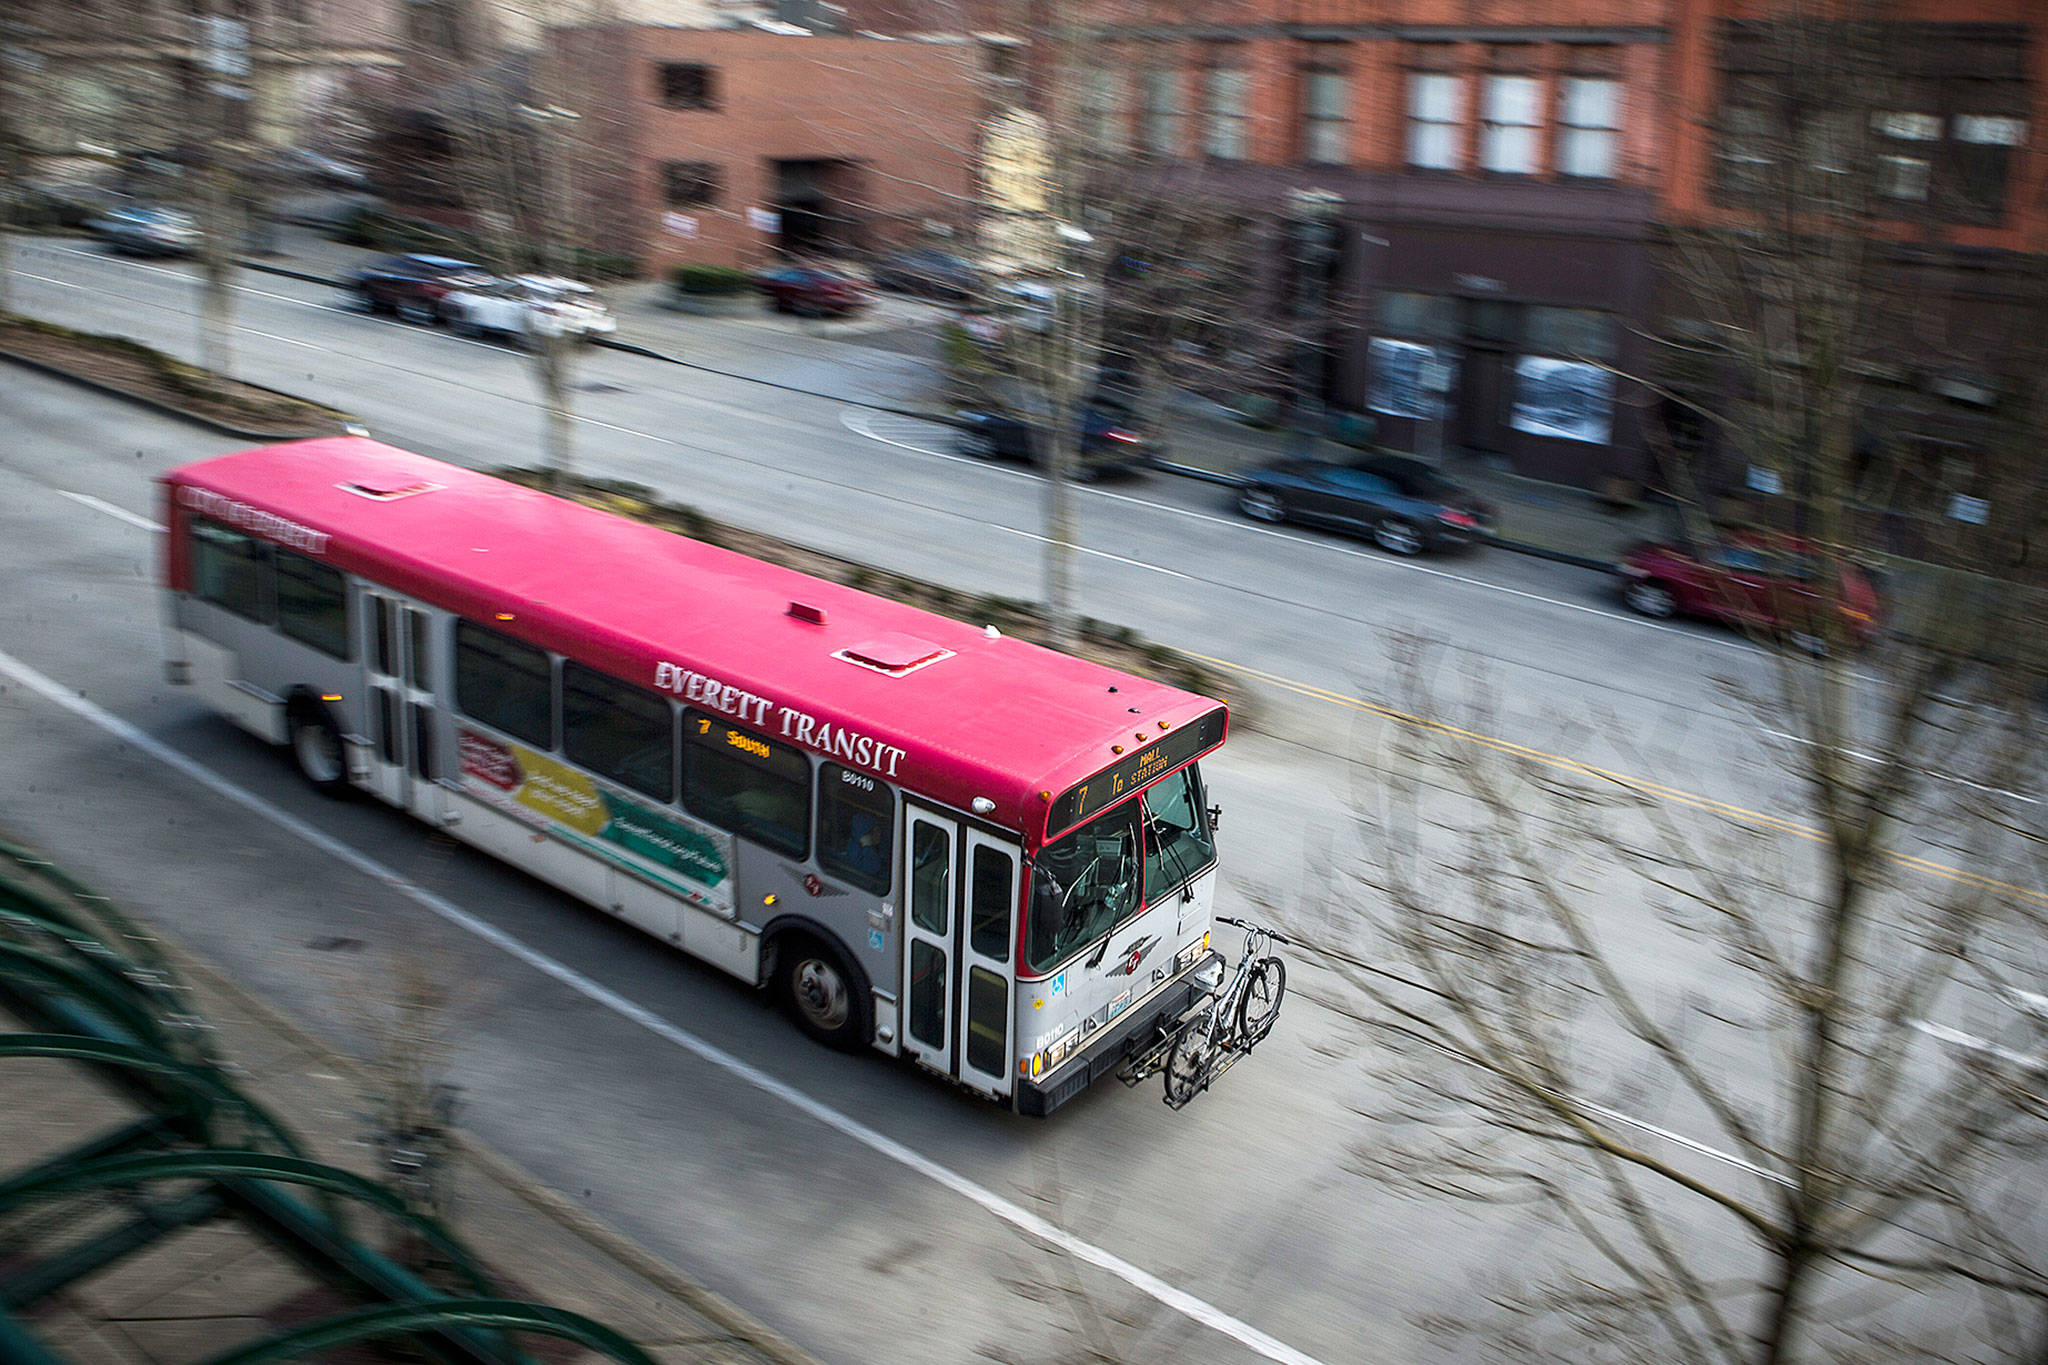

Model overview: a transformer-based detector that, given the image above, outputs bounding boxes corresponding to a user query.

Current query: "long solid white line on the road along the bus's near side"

[0,651,1321,1365]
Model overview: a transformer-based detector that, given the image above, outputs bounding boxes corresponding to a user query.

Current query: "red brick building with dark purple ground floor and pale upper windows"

[1040,0,1669,483]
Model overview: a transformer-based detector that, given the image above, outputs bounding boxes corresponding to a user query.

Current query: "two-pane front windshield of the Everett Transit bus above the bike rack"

[1024,763,1217,972]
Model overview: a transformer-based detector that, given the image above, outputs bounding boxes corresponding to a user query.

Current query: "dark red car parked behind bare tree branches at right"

[1620,536,1878,647]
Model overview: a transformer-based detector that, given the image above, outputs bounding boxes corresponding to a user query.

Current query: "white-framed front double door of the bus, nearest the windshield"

[903,802,1018,1099]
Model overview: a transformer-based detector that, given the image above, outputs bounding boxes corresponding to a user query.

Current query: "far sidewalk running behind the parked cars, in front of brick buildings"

[244,227,1671,569]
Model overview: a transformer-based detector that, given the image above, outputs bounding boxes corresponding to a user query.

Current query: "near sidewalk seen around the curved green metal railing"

[0,843,815,1365]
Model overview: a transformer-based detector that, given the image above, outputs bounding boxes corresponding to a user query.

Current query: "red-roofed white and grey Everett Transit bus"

[164,436,1227,1113]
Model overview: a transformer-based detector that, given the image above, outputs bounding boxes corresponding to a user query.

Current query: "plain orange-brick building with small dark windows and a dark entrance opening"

[551,27,981,272]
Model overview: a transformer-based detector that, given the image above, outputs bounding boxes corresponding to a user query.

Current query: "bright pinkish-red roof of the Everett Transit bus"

[164,436,1223,837]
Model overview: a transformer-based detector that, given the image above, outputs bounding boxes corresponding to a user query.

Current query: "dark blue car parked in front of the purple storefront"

[1237,454,1495,555]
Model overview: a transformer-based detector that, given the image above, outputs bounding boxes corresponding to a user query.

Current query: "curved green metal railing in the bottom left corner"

[0,841,653,1365]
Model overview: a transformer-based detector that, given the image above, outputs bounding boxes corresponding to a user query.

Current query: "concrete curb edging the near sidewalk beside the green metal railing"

[138,900,819,1365]
